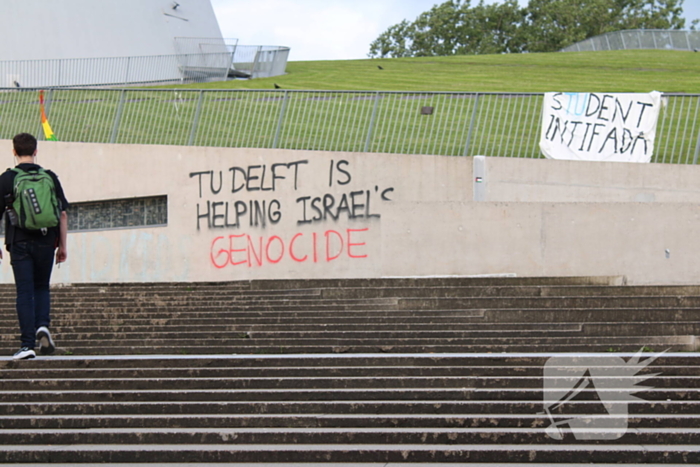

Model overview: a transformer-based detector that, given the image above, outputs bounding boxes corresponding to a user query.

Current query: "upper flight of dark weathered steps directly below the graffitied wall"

[0,278,700,355]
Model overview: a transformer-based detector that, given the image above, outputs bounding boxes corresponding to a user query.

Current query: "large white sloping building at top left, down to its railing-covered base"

[0,0,289,88]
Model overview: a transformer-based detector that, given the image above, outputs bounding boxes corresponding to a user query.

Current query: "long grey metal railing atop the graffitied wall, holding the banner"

[0,89,700,164]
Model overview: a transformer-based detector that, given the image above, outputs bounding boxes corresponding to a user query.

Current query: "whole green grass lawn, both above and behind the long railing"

[0,50,700,163]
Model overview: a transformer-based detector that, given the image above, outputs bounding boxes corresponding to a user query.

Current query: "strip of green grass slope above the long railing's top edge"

[163,50,700,94]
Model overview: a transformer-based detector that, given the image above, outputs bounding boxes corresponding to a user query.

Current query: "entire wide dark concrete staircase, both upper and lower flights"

[0,278,700,465]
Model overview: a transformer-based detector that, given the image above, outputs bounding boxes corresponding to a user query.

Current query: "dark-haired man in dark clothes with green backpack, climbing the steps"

[0,133,68,360]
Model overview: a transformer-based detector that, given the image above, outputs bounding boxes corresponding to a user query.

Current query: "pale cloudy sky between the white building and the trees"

[211,0,700,61]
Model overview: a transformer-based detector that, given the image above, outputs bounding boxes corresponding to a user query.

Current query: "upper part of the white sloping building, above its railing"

[0,0,223,61]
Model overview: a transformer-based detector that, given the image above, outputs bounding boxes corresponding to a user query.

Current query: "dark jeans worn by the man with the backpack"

[10,241,55,349]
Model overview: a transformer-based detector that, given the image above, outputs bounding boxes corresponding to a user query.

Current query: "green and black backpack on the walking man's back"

[12,167,61,231]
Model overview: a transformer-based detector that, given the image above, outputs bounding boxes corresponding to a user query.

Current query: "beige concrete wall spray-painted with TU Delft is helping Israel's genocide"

[0,141,700,284]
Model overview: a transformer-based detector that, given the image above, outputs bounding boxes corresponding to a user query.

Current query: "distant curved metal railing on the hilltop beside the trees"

[561,29,700,52]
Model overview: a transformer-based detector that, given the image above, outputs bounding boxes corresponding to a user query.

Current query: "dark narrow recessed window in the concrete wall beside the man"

[68,196,168,231]
